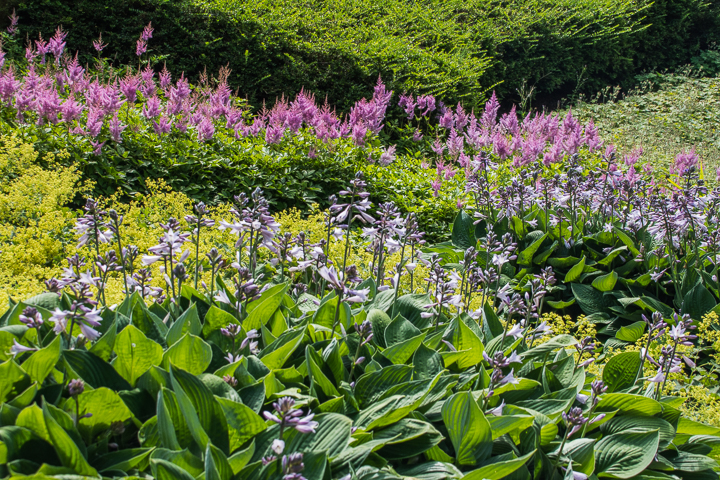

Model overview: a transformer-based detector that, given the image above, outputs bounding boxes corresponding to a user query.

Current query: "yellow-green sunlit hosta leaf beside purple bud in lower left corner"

[72,387,133,438]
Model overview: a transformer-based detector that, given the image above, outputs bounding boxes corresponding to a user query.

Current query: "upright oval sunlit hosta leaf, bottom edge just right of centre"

[442,392,492,465]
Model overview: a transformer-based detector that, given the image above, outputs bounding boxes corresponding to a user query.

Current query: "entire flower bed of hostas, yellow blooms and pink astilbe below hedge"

[0,14,720,480]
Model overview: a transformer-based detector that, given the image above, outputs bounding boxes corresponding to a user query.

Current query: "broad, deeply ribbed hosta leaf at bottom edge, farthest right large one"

[595,431,660,478]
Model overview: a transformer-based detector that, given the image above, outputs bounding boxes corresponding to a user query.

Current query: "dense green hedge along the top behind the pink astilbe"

[5,0,720,109]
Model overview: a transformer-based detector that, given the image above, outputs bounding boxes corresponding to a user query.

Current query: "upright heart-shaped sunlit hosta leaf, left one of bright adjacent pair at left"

[113,325,163,387]
